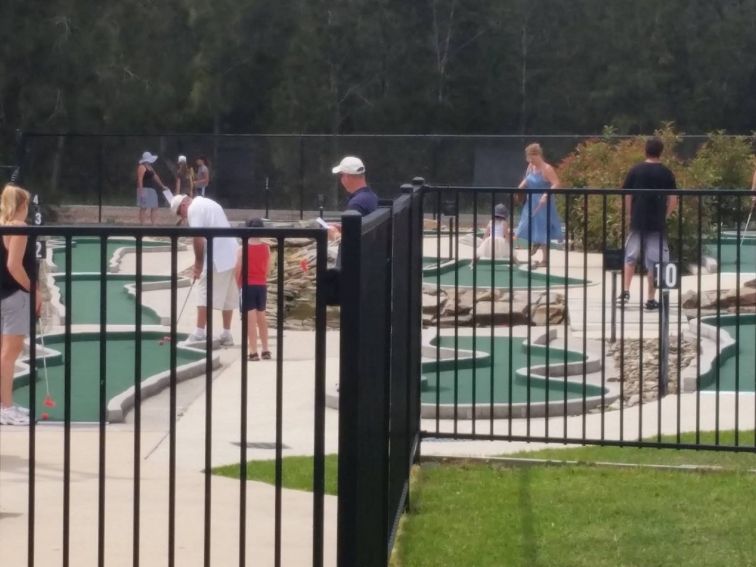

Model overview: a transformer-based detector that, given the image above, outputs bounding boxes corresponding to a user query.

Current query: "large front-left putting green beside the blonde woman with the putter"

[13,331,205,421]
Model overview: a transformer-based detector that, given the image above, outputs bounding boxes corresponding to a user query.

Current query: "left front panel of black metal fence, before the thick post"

[0,226,335,566]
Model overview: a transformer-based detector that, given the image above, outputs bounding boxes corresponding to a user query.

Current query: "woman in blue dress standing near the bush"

[515,144,562,268]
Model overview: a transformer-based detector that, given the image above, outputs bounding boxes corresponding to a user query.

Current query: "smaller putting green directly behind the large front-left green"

[55,274,168,325]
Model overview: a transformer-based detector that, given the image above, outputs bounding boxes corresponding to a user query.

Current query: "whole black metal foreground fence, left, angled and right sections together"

[5,180,756,566]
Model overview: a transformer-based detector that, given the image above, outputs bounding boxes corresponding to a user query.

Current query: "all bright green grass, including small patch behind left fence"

[208,431,756,567]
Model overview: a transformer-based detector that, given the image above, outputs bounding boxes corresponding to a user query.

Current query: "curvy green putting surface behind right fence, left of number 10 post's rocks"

[421,336,601,404]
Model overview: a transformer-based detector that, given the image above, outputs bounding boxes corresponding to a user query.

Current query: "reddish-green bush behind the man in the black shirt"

[559,124,753,264]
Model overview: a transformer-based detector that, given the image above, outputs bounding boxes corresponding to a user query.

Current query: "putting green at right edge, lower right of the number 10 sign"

[701,314,756,392]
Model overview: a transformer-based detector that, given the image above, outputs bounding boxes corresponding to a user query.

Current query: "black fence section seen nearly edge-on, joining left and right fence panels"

[338,186,422,567]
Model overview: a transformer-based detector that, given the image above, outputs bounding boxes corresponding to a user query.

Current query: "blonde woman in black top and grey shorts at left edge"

[0,184,42,425]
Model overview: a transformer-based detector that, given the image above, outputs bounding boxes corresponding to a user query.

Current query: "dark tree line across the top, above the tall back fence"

[0,0,756,156]
